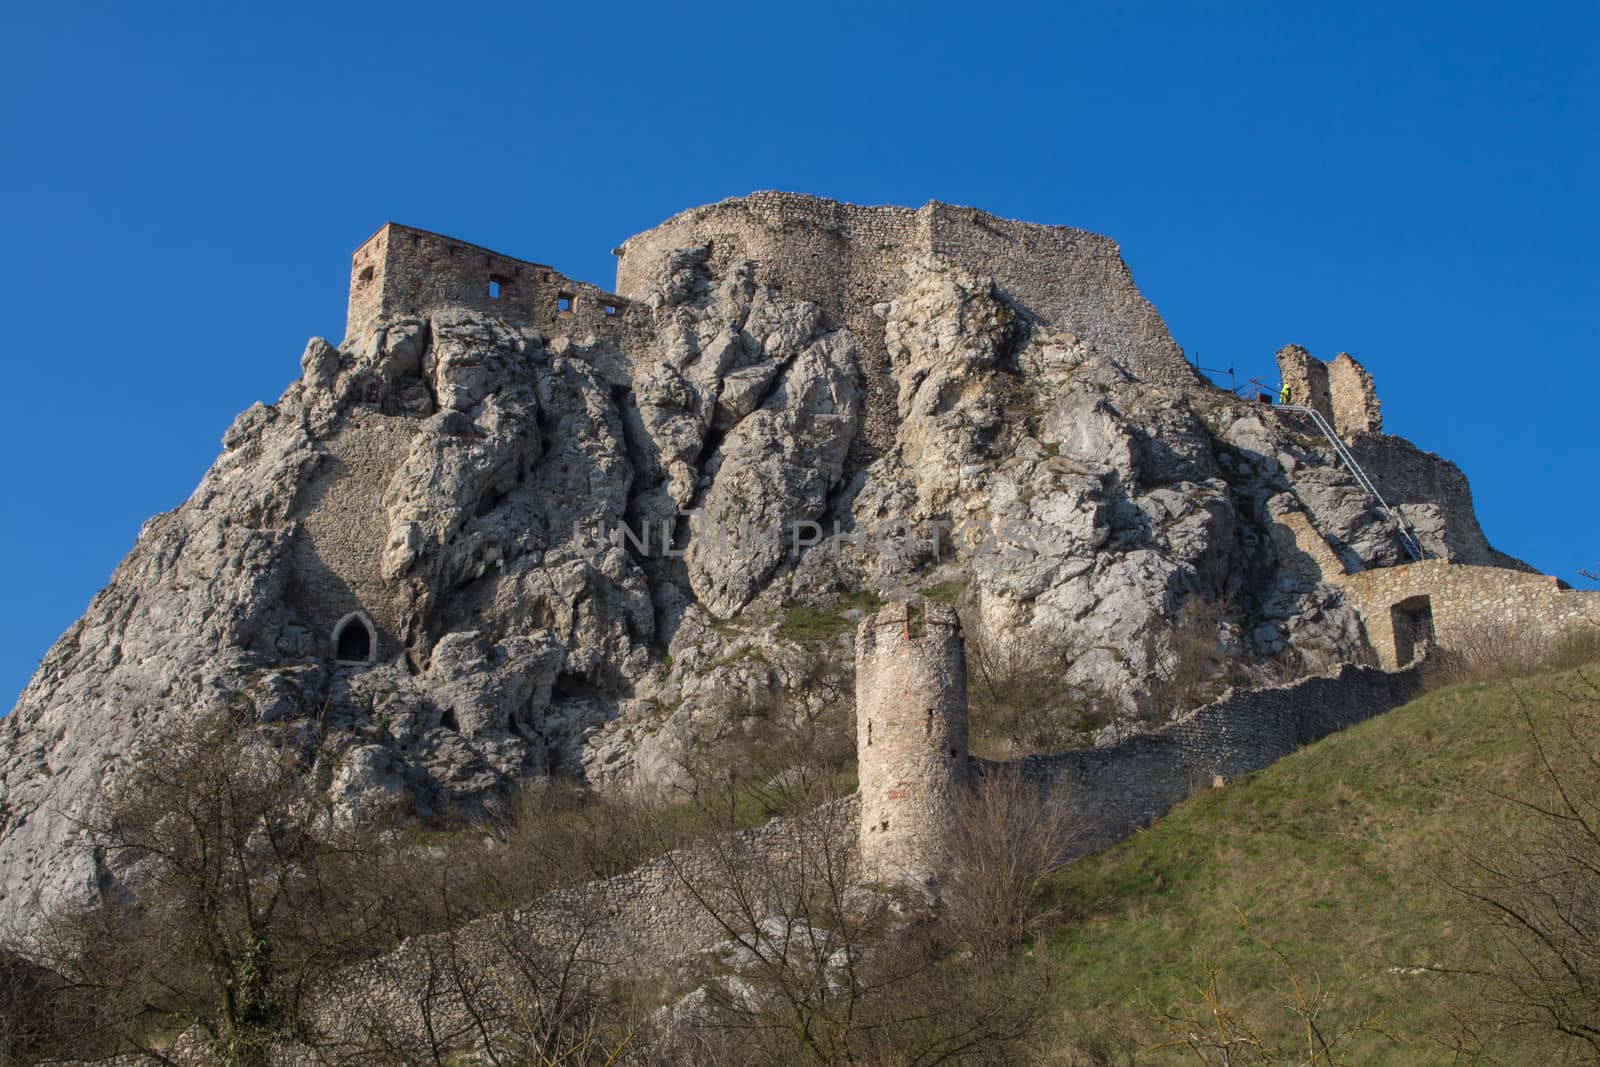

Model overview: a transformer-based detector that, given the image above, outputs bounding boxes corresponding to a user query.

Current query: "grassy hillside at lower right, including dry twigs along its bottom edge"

[1042,669,1595,1064]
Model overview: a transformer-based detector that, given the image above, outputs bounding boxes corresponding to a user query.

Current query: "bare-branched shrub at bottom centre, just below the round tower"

[661,729,1045,1065]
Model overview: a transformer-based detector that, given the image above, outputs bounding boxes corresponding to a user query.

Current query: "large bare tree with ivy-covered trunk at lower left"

[7,715,400,1064]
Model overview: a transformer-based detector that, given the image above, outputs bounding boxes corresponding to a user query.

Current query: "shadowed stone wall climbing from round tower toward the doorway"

[990,664,1419,853]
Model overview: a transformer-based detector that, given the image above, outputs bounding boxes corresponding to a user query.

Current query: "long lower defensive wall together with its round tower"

[318,605,1452,1048]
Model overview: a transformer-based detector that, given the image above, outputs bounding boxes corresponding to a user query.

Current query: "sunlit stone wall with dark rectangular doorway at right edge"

[1334,560,1600,667]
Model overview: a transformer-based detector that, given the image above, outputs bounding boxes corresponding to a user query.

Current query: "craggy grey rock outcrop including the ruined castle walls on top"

[0,194,1515,923]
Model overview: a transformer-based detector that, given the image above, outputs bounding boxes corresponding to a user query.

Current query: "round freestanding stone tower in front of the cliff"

[856,603,971,885]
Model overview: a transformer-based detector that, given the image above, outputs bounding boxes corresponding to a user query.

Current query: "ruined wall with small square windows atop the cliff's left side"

[344,222,627,338]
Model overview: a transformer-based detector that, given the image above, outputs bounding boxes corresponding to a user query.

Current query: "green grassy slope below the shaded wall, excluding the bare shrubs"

[1046,669,1600,1064]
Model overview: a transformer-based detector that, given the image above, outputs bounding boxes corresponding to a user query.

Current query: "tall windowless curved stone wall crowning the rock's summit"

[616,192,1197,453]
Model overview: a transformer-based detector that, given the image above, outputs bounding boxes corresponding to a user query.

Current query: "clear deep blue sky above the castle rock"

[0,0,1600,710]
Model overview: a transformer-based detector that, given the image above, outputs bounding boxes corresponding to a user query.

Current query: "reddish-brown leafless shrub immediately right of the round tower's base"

[944,766,1086,965]
